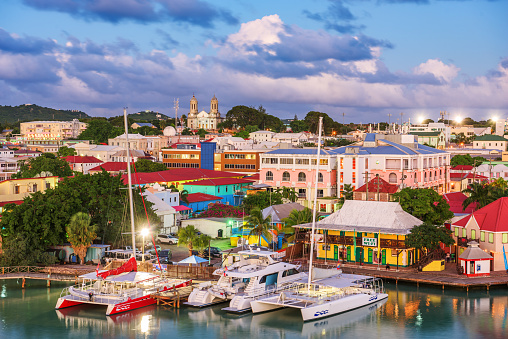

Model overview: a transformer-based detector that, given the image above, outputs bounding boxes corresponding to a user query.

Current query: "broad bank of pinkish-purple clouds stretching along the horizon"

[0,13,508,121]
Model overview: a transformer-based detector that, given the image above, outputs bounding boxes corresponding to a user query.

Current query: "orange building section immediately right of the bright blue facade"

[214,150,267,173]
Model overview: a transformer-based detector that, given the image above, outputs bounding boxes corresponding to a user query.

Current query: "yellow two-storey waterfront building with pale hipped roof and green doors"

[296,200,422,267]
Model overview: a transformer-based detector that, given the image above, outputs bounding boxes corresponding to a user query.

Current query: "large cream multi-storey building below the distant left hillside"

[19,119,87,143]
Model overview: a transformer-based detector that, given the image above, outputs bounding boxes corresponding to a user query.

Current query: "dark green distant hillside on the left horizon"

[0,105,89,124]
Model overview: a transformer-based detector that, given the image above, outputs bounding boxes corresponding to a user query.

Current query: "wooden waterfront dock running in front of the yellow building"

[342,265,508,291]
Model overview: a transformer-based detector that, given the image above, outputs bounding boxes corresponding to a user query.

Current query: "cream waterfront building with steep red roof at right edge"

[452,197,508,271]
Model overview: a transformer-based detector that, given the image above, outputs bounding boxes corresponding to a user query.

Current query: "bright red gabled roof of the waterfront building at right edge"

[453,197,508,232]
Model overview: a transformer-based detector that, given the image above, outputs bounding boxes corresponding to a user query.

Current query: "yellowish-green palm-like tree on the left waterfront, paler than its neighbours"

[65,212,97,265]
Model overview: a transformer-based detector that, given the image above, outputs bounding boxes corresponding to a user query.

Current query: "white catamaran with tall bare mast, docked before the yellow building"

[251,117,388,321]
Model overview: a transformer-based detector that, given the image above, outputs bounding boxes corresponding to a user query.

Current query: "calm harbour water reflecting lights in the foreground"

[0,280,508,339]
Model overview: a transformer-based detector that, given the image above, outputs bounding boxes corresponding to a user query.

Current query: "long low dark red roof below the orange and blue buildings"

[122,168,242,185]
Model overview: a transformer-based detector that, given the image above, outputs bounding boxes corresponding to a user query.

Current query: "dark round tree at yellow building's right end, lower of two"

[404,223,455,262]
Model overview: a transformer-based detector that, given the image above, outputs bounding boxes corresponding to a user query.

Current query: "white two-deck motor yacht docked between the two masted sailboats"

[185,248,306,313]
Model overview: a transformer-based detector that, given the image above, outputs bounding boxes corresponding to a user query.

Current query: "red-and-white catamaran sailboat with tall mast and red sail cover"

[55,109,192,315]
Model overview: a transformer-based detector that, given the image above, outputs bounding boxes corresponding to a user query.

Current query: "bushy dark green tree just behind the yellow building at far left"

[12,153,73,179]
